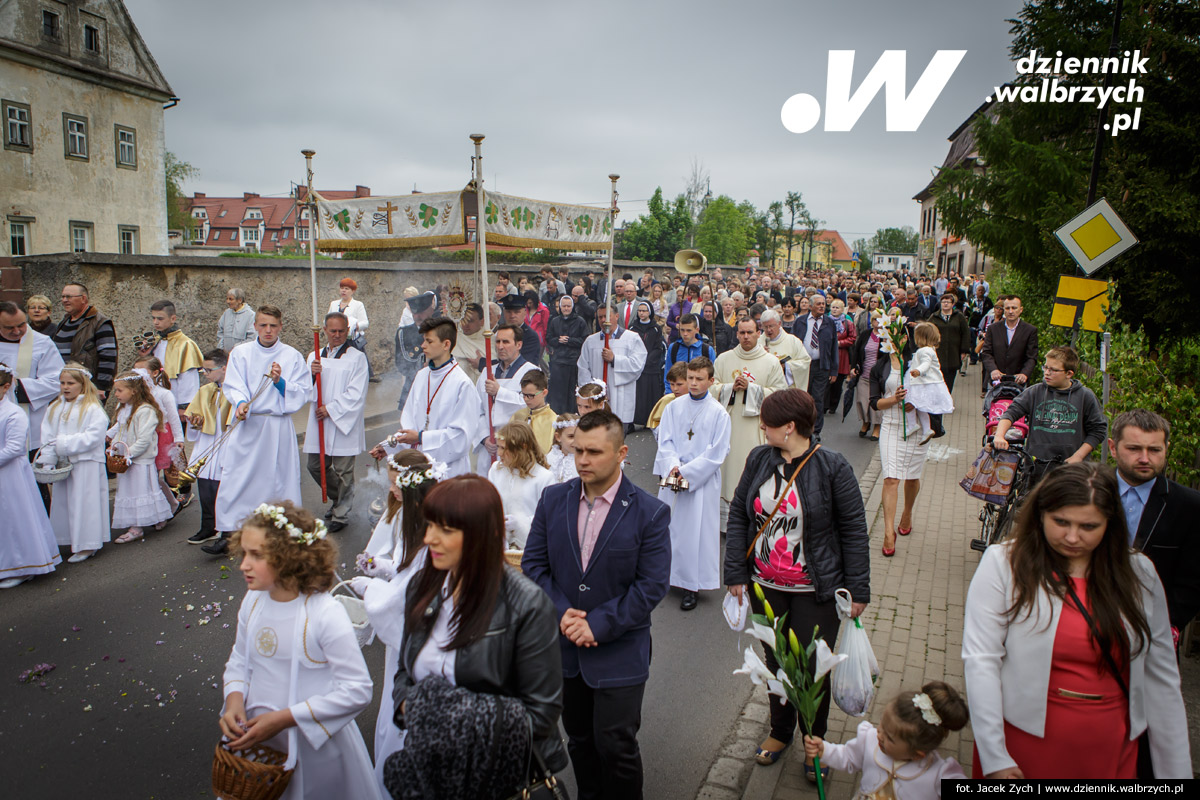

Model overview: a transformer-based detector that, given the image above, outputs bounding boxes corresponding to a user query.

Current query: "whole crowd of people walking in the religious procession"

[0,267,1200,799]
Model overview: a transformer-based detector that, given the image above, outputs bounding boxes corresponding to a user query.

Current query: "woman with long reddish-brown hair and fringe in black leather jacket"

[392,475,566,798]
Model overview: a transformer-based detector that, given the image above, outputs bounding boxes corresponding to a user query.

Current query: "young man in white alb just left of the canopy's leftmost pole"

[216,306,312,530]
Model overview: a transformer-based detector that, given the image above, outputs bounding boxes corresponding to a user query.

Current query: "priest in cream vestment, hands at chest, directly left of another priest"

[710,319,787,530]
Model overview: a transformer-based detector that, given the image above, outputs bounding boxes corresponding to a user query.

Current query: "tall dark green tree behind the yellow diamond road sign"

[935,0,1200,348]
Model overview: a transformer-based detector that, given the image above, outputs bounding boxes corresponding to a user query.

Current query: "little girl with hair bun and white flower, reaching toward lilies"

[804,680,968,800]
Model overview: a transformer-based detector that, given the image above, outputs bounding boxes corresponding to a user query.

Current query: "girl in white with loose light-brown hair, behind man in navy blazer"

[487,422,553,551]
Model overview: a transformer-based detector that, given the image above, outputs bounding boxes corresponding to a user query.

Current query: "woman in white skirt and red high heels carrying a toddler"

[870,337,929,557]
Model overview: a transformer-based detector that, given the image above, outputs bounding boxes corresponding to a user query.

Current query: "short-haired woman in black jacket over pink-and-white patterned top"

[725,389,871,781]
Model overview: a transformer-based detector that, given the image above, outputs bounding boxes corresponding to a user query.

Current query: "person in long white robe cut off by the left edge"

[0,361,62,589]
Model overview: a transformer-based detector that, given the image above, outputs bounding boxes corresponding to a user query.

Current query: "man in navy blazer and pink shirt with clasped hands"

[521,410,671,800]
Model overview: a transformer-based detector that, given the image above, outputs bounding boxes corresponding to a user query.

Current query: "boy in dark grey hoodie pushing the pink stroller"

[992,347,1108,464]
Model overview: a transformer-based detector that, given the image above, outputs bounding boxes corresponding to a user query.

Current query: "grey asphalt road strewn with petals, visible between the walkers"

[0,395,874,800]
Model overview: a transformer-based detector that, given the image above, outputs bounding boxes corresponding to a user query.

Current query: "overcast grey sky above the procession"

[126,0,1021,241]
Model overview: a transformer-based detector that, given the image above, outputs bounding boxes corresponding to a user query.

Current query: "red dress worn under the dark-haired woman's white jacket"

[972,578,1138,780]
